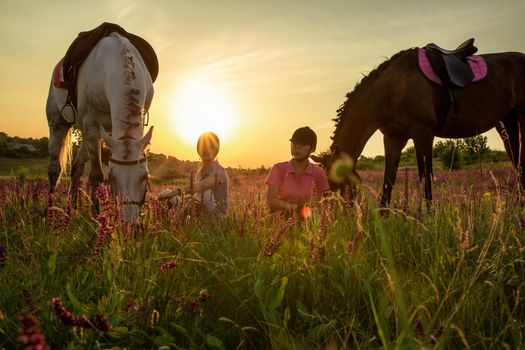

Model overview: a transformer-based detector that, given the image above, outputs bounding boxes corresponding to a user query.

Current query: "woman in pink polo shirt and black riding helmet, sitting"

[264,126,329,212]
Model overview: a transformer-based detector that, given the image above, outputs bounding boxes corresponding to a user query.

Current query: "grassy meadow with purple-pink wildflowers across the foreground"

[0,168,525,349]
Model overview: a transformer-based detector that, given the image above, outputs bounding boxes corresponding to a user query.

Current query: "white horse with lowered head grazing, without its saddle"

[46,33,153,222]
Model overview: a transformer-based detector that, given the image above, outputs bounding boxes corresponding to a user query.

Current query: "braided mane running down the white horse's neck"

[112,33,142,131]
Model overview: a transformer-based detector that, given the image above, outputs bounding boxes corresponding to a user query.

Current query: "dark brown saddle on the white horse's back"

[57,22,159,123]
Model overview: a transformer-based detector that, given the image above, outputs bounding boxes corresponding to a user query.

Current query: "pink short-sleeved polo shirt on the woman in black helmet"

[264,160,329,204]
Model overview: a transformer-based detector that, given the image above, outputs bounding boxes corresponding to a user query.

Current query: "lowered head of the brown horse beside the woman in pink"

[310,147,361,195]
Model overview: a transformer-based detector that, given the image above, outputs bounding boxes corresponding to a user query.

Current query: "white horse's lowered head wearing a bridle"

[100,126,153,222]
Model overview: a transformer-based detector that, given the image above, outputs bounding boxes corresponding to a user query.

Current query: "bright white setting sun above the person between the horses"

[171,80,237,144]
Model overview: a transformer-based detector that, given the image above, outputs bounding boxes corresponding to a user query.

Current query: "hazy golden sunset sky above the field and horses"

[0,0,525,167]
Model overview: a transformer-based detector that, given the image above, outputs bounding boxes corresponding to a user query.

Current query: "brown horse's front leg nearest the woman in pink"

[381,135,408,207]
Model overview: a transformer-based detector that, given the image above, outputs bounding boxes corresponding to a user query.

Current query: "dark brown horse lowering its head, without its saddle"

[313,48,525,206]
